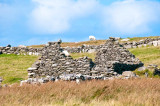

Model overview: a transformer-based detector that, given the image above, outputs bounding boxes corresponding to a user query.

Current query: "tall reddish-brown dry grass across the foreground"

[0,78,160,106]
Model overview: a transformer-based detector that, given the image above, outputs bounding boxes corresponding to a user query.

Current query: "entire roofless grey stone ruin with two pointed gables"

[28,38,143,78]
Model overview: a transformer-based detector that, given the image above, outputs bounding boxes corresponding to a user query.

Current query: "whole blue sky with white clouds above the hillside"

[0,0,160,46]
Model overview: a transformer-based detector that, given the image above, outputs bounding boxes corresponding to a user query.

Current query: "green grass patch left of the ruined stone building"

[0,54,38,84]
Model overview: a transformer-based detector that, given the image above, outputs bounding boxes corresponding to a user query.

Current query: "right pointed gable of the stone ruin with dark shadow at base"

[95,38,143,74]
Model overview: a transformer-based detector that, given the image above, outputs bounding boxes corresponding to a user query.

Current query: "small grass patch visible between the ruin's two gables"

[71,53,96,61]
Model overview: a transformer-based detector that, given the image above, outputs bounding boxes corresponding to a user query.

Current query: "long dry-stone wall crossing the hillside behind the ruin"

[0,38,160,55]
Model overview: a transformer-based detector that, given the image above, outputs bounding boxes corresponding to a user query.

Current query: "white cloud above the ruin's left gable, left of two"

[30,0,98,34]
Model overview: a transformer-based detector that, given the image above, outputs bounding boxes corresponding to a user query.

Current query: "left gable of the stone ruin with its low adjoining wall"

[28,42,94,77]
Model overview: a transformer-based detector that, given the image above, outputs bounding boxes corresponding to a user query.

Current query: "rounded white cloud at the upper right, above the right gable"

[103,0,160,34]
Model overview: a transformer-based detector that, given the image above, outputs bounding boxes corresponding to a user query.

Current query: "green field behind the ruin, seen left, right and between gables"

[0,46,160,84]
